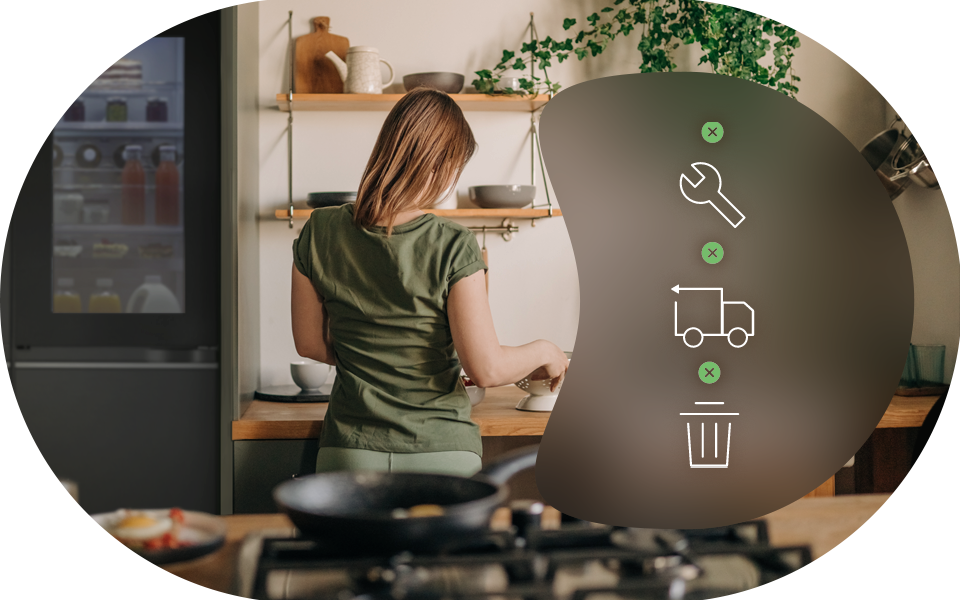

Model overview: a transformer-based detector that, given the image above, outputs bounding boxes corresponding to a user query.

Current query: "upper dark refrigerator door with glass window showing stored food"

[13,0,220,347]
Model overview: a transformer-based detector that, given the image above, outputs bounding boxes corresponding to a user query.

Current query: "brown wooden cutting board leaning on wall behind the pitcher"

[293,17,350,94]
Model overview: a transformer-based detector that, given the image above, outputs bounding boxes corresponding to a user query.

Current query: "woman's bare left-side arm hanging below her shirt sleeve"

[290,266,337,365]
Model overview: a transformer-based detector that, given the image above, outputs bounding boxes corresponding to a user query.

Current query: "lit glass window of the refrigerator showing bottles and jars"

[51,37,190,313]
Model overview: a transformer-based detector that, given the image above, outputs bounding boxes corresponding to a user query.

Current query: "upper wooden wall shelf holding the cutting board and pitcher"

[277,94,550,112]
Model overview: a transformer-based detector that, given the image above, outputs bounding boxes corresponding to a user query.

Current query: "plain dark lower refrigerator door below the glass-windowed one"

[13,364,220,514]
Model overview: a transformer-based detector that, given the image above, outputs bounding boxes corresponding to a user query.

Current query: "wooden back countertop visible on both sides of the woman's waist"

[233,385,550,440]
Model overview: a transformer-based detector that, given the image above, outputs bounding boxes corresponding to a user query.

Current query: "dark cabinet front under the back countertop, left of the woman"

[233,439,319,514]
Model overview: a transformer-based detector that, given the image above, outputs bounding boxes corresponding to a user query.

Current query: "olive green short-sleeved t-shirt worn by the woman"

[293,204,486,455]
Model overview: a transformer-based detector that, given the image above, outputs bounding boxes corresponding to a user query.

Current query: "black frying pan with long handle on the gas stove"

[273,446,539,554]
